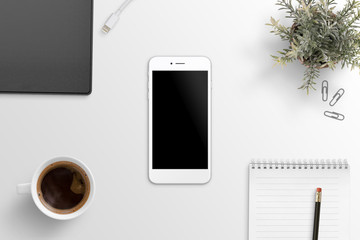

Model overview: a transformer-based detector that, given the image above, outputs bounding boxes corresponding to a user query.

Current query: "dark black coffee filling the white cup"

[38,162,89,214]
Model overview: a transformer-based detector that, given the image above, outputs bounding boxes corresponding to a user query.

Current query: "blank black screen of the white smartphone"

[152,71,209,169]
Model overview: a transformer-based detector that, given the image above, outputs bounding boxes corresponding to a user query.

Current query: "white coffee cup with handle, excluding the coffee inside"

[17,157,95,220]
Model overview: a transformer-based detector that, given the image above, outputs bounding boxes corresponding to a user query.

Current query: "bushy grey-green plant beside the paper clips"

[267,0,360,94]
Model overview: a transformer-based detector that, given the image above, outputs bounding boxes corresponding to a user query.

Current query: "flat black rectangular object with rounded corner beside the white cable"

[0,0,93,94]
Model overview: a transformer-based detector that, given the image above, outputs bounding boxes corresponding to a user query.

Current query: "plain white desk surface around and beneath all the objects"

[0,0,360,240]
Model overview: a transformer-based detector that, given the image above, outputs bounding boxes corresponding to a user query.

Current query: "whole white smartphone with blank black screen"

[148,57,212,184]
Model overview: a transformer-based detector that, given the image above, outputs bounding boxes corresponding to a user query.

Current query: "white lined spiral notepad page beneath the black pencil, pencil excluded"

[249,160,350,240]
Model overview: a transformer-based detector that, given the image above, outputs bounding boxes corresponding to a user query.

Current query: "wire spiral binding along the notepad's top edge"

[250,159,349,169]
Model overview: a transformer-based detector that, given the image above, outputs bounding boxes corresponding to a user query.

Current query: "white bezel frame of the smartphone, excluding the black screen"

[148,57,212,184]
